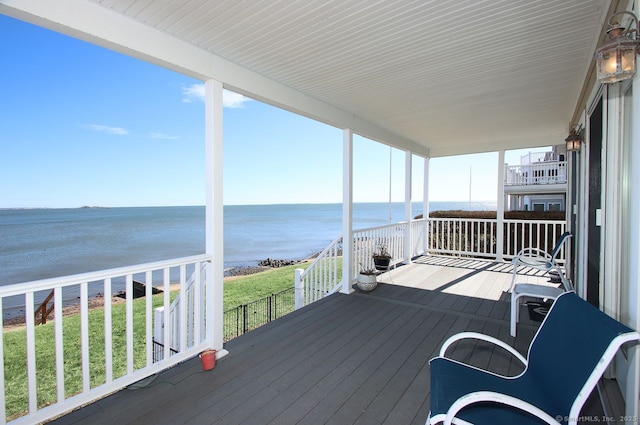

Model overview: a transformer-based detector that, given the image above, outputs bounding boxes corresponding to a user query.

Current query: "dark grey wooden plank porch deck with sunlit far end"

[54,257,597,425]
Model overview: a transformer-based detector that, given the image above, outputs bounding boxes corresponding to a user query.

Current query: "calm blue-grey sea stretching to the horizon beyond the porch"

[0,202,496,285]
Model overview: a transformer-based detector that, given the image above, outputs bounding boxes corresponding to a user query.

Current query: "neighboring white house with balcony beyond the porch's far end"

[504,145,567,211]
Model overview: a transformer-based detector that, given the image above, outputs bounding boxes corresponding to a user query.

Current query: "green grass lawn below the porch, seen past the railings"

[4,264,308,419]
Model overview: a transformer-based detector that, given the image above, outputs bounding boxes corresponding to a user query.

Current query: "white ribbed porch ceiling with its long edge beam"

[0,0,610,156]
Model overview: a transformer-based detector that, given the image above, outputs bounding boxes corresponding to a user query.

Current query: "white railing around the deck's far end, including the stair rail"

[295,218,566,309]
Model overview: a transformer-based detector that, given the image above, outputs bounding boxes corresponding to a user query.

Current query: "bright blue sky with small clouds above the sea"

[0,15,548,208]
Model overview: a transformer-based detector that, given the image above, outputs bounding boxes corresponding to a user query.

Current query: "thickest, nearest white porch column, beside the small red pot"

[205,80,227,357]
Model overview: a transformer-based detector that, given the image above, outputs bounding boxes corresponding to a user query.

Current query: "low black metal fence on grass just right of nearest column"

[224,288,295,341]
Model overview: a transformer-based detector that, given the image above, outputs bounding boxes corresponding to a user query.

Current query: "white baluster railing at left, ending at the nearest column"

[0,255,212,424]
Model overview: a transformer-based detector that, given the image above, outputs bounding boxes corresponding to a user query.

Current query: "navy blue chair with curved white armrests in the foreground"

[426,292,640,425]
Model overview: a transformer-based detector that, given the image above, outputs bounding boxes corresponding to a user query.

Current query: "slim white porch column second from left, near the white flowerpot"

[340,128,353,294]
